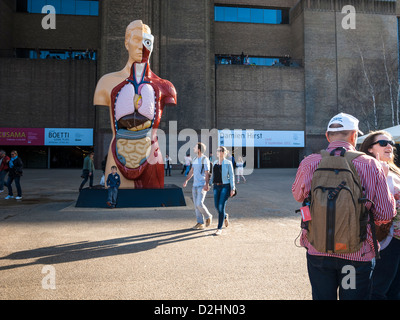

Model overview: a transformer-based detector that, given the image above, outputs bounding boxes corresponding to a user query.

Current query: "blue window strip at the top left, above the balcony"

[17,0,99,16]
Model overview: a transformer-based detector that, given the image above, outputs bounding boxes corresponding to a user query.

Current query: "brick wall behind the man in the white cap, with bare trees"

[299,1,398,153]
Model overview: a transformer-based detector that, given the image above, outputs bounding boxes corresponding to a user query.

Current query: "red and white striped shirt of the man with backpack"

[292,141,396,261]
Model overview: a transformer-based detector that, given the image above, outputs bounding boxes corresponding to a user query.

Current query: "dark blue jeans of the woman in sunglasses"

[372,238,400,300]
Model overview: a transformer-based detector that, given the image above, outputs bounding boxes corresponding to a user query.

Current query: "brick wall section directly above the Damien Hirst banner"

[217,65,305,130]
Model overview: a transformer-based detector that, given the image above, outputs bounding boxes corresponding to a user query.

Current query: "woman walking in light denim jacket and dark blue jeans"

[210,147,235,236]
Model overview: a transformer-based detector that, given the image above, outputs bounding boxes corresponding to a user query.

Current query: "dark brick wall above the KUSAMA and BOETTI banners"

[0,58,96,128]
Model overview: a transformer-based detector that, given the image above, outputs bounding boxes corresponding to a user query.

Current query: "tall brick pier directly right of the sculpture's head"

[160,0,214,130]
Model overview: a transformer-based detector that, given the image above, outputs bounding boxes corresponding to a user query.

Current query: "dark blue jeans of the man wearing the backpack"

[307,254,372,300]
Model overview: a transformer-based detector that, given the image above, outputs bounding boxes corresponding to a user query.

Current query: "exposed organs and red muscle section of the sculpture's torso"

[111,63,176,189]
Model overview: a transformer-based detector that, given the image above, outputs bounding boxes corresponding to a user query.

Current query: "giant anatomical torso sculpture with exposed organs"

[94,20,176,189]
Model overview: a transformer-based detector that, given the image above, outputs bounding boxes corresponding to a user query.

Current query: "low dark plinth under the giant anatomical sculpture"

[75,184,186,208]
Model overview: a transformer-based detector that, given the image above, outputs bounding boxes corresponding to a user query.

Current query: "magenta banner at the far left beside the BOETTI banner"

[0,128,44,146]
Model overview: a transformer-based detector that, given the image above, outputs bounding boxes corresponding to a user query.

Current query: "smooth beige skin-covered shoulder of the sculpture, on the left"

[93,71,126,106]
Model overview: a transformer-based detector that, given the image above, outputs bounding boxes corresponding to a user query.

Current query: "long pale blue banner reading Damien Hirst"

[218,129,304,148]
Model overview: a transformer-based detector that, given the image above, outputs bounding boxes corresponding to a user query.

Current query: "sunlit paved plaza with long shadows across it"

[0,169,311,300]
